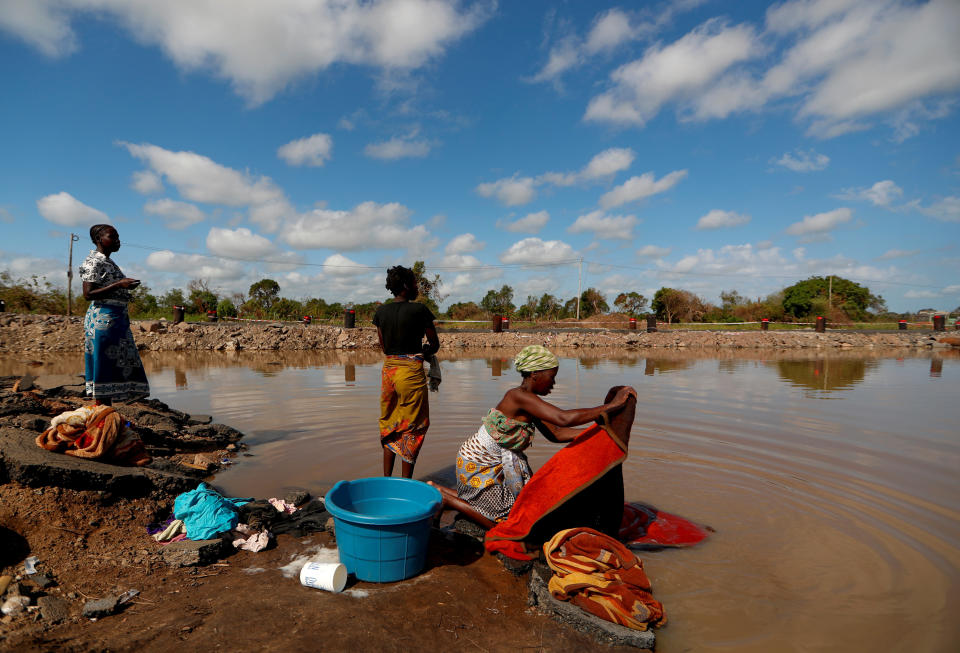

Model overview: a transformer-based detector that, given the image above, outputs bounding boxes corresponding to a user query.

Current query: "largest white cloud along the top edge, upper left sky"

[0,0,492,105]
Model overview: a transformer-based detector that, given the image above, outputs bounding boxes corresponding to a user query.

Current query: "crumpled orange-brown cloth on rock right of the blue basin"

[543,528,667,630]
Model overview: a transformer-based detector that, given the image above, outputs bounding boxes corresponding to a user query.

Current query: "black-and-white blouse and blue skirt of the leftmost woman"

[80,251,150,400]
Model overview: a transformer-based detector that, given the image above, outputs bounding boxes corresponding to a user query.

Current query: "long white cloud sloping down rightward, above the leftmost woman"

[121,143,285,206]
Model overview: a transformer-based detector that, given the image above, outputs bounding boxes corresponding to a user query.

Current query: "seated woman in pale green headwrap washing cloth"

[431,345,636,528]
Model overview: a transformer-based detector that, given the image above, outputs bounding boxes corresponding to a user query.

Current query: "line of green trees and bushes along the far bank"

[0,268,948,323]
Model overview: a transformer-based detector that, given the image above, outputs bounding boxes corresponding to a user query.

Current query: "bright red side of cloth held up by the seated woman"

[485,424,627,560]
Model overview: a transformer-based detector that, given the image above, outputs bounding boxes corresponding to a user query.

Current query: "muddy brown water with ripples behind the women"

[0,351,960,653]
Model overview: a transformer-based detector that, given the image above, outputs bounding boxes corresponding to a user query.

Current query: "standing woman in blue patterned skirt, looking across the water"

[80,224,150,405]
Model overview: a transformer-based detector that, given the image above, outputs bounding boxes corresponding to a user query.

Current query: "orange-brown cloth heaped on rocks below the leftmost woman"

[36,406,150,465]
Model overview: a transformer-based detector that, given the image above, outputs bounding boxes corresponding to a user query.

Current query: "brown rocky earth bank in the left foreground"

[0,375,652,651]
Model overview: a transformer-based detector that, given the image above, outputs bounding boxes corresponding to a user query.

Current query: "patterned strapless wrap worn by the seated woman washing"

[457,408,534,521]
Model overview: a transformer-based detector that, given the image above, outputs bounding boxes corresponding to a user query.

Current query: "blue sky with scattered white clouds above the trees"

[0,0,960,310]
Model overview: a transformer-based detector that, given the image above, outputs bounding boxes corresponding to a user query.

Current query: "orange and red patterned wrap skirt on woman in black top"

[380,355,430,463]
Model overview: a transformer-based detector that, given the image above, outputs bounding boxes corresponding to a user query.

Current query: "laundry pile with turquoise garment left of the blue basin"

[147,483,330,552]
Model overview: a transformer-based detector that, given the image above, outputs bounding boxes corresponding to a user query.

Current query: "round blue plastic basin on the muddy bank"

[324,477,443,583]
